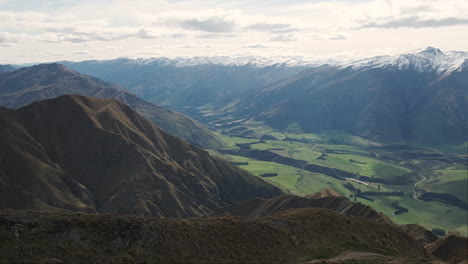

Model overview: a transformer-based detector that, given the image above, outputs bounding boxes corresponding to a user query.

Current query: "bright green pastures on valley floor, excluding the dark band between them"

[219,125,468,235]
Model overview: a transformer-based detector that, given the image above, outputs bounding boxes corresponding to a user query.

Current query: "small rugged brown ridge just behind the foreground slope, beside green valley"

[211,191,391,223]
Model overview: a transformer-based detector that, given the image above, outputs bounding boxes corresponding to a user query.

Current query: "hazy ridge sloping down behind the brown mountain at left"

[0,63,223,148]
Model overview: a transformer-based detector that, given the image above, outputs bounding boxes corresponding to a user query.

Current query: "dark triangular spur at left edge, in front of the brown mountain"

[0,108,96,213]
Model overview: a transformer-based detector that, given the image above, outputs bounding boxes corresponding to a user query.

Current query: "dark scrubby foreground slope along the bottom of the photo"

[0,209,434,263]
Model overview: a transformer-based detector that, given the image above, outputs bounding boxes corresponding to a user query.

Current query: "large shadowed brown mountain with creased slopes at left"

[0,96,281,217]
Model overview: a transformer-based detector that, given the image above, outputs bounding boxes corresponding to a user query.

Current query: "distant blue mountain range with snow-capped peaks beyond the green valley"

[59,47,468,145]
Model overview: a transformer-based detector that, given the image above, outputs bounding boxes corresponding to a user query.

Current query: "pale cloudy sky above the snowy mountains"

[0,0,468,64]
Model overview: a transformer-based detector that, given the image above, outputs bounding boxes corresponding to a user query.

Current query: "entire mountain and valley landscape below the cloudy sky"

[0,47,468,263]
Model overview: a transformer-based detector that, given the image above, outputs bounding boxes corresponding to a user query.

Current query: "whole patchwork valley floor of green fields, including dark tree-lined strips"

[214,126,468,235]
